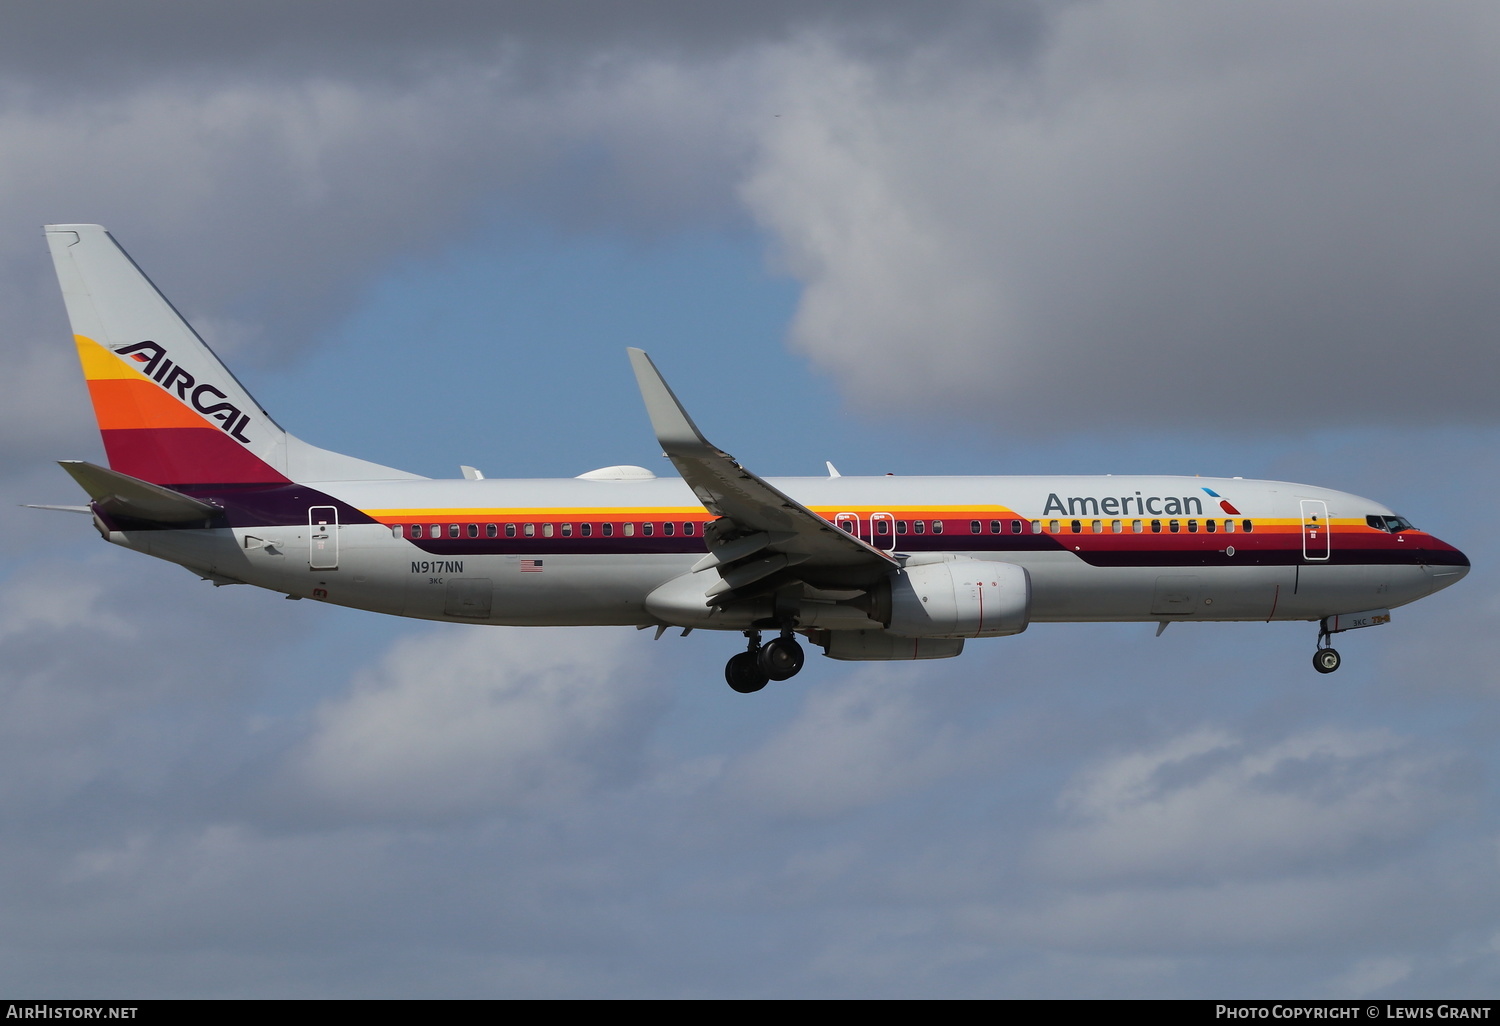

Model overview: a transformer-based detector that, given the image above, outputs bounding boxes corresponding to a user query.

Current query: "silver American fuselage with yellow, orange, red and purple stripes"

[105,477,1467,627]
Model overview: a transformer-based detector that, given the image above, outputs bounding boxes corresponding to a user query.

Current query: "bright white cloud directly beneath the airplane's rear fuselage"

[291,627,662,821]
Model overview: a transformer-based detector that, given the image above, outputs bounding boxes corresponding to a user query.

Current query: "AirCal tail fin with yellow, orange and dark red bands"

[47,225,416,486]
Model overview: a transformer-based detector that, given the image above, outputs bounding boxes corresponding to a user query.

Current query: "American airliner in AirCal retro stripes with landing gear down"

[41,225,1469,693]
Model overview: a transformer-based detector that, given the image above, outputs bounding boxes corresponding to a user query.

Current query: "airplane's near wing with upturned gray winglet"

[629,350,899,597]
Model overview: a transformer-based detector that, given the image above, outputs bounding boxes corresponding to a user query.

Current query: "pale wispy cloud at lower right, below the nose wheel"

[1035,728,1467,881]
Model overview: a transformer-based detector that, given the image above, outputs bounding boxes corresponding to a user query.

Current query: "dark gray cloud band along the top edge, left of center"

[0,0,1059,95]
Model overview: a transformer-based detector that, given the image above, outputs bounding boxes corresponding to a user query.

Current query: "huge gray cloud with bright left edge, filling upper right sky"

[746,3,1500,432]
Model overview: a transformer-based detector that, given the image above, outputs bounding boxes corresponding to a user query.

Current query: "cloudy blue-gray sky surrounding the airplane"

[0,0,1500,998]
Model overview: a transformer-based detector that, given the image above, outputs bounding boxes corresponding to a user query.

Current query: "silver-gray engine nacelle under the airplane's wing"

[887,557,1031,638]
